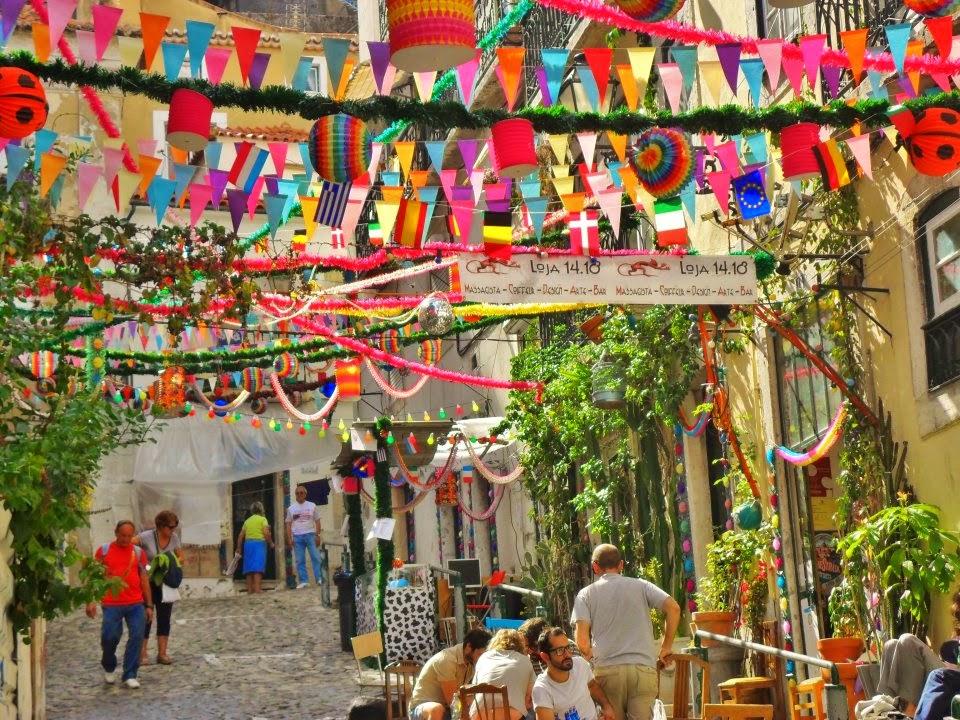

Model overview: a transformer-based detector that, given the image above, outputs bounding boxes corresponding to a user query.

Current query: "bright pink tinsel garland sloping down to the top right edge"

[535,0,960,75]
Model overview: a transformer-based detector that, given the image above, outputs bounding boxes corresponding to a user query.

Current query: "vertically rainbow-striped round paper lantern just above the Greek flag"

[309,113,373,182]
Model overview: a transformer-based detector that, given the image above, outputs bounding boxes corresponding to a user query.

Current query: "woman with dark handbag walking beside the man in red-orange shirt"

[133,510,183,665]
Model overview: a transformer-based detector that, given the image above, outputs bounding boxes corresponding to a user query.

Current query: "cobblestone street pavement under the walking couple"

[47,587,382,720]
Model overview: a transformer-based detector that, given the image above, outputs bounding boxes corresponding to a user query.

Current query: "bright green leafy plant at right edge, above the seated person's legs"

[837,500,960,637]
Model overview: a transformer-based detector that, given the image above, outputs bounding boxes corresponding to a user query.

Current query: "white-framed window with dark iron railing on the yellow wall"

[917,188,960,389]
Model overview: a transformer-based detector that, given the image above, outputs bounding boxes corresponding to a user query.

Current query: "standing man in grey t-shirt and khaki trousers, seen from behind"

[570,544,680,720]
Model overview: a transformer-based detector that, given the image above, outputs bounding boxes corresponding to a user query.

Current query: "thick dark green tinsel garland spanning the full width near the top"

[0,51,944,135]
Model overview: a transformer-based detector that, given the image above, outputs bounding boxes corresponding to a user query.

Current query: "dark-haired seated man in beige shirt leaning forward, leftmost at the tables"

[410,628,490,720]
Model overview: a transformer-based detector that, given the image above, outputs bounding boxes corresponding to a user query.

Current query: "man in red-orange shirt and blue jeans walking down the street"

[87,520,153,688]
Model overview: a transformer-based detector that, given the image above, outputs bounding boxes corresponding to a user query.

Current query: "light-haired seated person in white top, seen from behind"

[470,630,536,720]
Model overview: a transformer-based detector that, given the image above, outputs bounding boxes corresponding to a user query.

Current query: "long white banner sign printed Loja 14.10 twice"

[458,255,757,305]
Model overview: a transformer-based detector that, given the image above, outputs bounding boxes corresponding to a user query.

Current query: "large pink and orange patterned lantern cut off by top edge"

[387,0,477,72]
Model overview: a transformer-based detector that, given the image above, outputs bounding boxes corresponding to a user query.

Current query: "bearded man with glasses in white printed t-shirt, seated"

[533,627,614,720]
